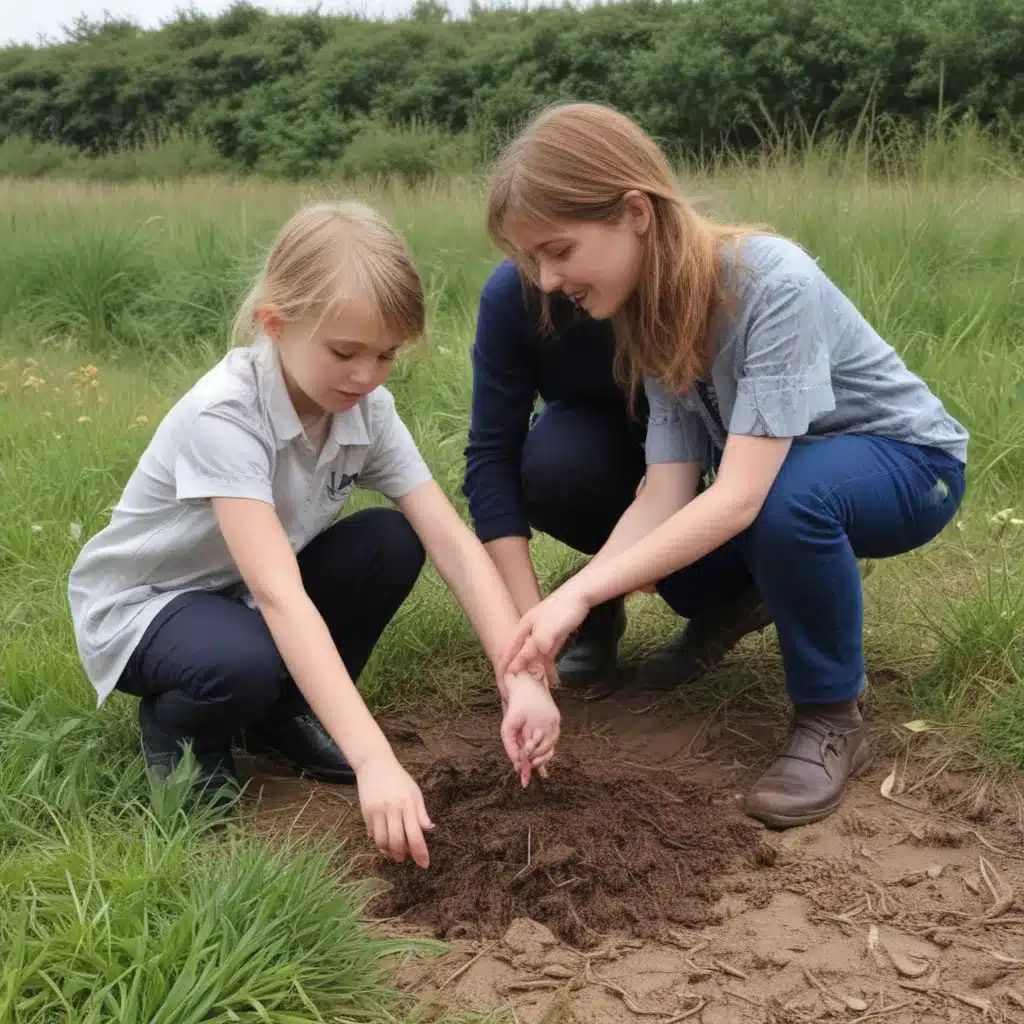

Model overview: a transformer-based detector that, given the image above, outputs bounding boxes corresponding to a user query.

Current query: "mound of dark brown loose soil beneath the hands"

[372,757,775,948]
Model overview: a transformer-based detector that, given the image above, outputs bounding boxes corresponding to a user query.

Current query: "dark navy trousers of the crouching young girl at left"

[118,508,424,742]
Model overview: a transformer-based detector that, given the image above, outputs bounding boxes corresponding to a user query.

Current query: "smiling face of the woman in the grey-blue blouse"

[509,193,653,319]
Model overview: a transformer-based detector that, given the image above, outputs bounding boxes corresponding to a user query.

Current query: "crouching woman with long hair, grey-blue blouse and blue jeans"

[488,104,967,827]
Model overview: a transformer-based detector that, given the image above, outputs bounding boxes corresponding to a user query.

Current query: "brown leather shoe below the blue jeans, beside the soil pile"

[745,700,870,828]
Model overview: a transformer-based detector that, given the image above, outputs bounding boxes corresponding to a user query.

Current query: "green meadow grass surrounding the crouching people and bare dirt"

[0,132,1024,1024]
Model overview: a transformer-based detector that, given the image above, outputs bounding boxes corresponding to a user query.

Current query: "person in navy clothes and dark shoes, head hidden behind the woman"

[463,260,768,685]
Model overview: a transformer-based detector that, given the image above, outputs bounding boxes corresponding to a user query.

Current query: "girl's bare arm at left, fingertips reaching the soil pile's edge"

[212,498,433,867]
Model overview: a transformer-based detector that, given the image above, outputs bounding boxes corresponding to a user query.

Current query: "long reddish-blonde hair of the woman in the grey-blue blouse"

[487,103,770,397]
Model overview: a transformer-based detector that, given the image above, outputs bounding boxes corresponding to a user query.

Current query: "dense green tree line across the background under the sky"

[0,0,1024,177]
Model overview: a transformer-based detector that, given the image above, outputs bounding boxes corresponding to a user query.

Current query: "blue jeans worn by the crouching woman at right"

[657,434,965,703]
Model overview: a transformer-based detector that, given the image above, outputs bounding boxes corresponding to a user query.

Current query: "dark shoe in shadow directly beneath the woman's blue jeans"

[637,584,771,689]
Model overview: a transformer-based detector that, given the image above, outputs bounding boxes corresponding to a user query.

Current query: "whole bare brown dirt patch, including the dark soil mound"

[243,694,1024,1024]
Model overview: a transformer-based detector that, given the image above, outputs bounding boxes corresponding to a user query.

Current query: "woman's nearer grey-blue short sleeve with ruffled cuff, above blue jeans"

[729,275,836,437]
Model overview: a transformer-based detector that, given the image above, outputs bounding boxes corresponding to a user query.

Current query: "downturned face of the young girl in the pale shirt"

[257,302,402,416]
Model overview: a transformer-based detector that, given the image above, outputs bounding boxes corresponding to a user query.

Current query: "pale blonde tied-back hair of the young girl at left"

[231,201,426,345]
